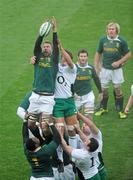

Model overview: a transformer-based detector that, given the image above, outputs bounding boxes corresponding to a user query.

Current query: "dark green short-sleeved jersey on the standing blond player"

[97,36,129,69]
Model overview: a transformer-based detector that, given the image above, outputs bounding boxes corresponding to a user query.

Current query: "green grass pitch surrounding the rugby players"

[0,0,133,180]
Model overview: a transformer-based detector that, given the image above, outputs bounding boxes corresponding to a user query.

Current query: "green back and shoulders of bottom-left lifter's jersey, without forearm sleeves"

[24,141,58,178]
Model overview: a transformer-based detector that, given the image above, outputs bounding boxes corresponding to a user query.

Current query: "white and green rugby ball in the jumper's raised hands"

[39,21,52,36]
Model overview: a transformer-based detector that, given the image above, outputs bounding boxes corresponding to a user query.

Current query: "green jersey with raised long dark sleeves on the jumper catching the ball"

[33,33,59,93]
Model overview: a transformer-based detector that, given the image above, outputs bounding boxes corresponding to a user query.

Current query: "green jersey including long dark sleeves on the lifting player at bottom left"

[22,122,61,178]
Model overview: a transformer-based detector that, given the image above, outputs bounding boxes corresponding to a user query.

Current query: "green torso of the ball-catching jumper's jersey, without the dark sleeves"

[33,55,58,93]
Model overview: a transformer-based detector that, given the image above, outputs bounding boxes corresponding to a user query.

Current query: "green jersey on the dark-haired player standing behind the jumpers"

[74,63,101,96]
